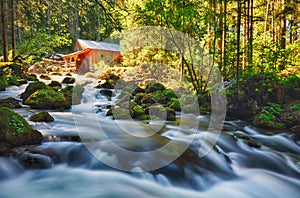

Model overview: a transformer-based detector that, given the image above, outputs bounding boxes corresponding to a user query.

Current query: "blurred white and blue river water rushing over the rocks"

[0,77,300,198]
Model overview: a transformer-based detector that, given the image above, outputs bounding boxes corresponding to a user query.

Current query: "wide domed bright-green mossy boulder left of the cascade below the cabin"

[24,89,71,109]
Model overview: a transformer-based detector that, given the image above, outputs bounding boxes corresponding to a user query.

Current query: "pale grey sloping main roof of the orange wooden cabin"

[76,39,120,52]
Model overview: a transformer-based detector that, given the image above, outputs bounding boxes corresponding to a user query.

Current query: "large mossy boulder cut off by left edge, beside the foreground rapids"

[0,107,43,146]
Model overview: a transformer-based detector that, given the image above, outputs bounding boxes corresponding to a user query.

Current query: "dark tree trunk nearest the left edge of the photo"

[1,0,8,62]
